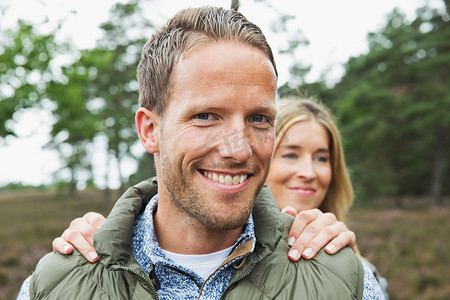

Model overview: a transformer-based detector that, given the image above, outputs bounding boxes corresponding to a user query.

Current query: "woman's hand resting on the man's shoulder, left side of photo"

[52,212,105,262]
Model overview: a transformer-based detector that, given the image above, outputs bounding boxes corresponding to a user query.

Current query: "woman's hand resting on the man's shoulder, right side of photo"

[281,206,356,261]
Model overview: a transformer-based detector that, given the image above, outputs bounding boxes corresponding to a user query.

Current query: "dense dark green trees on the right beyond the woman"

[326,7,450,203]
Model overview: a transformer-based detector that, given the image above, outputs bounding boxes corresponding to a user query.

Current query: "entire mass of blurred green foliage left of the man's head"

[0,0,157,193]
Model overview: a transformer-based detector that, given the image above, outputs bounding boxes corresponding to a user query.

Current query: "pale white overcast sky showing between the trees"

[0,0,443,187]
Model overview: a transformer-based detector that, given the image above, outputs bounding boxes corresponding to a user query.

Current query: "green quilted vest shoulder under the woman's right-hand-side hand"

[237,214,364,299]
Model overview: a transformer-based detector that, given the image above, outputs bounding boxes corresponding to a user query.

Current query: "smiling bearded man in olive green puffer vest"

[19,7,382,299]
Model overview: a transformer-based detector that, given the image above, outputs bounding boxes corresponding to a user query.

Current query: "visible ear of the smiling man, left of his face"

[135,107,159,153]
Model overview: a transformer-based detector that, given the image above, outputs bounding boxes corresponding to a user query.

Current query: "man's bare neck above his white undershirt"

[153,198,244,254]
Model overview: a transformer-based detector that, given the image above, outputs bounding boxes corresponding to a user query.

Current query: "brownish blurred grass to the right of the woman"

[349,200,450,300]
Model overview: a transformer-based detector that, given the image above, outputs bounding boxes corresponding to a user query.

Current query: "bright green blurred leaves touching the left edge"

[0,20,67,139]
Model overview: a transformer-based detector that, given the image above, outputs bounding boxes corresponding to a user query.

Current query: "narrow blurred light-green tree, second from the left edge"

[46,51,101,197]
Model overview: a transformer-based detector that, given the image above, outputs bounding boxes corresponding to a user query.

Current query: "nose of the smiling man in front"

[219,126,253,163]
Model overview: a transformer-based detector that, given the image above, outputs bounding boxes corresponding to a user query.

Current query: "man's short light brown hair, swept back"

[137,6,278,115]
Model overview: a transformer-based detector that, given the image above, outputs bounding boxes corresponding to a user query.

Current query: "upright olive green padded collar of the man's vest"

[94,177,283,266]
